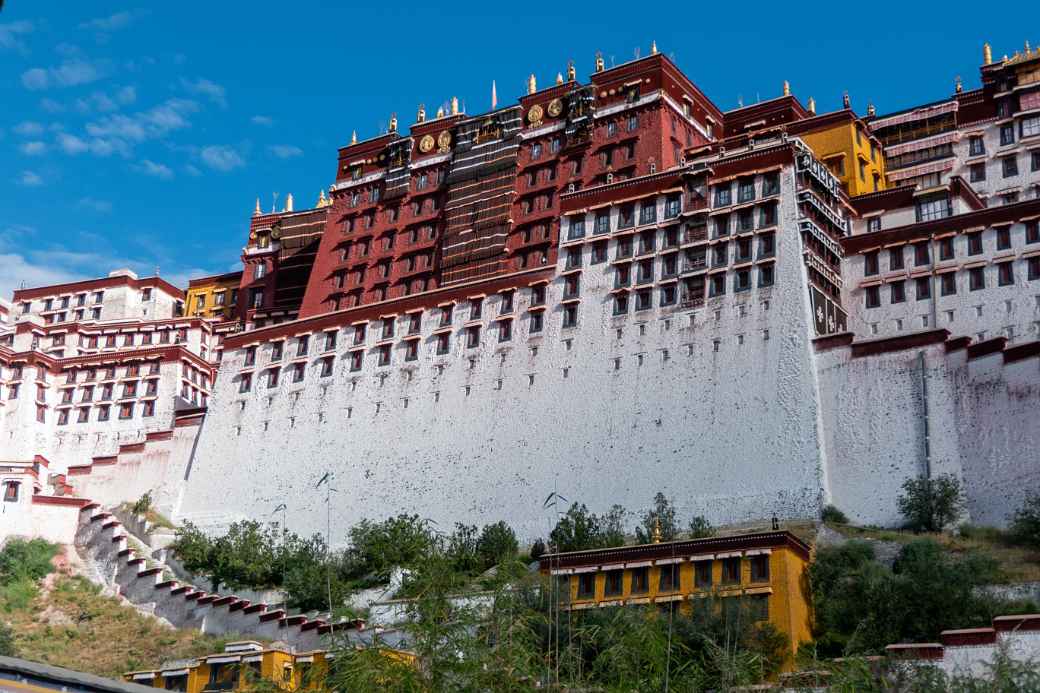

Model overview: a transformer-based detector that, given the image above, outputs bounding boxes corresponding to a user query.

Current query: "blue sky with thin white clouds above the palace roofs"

[0,0,1040,297]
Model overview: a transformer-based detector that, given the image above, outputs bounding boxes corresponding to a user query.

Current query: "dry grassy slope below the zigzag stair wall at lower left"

[0,574,240,677]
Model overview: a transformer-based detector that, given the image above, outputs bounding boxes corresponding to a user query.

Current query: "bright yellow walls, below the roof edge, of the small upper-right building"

[799,121,885,196]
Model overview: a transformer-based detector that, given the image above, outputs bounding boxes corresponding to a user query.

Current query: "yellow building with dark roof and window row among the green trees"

[539,532,812,655]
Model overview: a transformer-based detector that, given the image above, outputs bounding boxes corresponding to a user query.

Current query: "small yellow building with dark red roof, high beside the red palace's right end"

[788,109,886,197]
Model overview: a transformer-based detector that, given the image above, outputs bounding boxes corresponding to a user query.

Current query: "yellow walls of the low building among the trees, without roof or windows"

[569,548,812,665]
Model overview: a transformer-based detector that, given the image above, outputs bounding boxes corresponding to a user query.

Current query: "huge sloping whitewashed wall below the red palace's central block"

[178,166,823,539]
